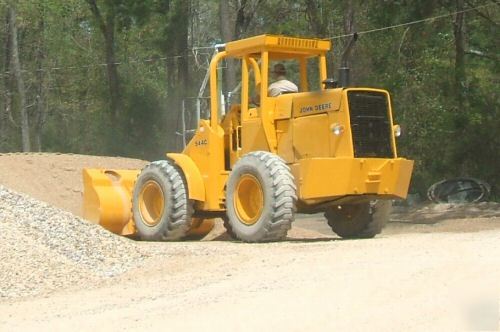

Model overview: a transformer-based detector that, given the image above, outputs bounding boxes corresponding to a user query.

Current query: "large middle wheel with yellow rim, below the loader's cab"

[224,151,297,242]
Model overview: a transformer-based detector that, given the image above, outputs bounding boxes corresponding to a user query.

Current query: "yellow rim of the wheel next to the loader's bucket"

[139,181,165,227]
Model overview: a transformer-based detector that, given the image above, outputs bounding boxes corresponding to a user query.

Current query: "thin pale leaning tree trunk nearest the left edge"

[9,6,31,152]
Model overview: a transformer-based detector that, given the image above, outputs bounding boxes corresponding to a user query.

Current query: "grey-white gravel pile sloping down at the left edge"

[0,186,150,298]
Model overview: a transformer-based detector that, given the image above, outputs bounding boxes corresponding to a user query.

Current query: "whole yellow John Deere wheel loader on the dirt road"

[83,35,413,242]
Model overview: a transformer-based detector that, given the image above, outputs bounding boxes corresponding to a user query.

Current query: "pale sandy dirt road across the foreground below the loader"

[0,224,500,331]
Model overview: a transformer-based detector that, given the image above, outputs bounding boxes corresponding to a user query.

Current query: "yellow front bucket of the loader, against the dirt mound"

[83,168,140,235]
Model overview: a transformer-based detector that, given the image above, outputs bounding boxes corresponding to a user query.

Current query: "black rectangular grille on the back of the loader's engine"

[347,91,394,158]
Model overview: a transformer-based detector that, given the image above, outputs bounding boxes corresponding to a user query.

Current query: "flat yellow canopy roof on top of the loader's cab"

[226,35,331,59]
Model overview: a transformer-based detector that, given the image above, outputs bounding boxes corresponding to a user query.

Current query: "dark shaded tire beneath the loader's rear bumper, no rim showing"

[325,200,392,239]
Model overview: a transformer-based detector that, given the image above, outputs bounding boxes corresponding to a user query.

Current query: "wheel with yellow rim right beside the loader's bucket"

[132,160,193,241]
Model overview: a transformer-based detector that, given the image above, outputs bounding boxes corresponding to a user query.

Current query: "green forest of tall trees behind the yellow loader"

[0,0,500,198]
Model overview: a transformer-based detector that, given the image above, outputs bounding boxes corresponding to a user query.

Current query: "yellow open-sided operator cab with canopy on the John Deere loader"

[211,35,331,170]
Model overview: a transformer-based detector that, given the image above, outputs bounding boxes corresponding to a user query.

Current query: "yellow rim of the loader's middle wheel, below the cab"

[233,174,264,226]
